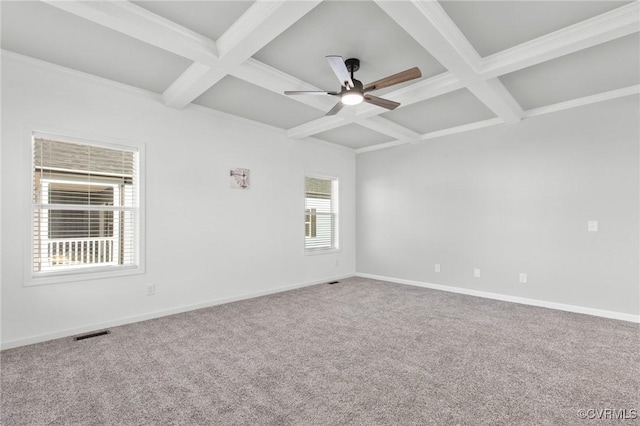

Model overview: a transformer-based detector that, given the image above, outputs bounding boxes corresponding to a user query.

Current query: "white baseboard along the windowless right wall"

[356,272,640,323]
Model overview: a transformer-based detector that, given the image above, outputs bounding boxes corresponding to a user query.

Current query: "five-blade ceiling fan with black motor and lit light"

[284,55,422,115]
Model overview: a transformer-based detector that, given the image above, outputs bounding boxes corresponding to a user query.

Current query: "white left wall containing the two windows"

[1,52,355,347]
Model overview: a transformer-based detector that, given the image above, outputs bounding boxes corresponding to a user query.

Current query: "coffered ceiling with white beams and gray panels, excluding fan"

[0,0,640,152]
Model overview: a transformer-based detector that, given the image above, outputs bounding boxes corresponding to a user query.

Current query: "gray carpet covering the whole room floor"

[1,278,640,426]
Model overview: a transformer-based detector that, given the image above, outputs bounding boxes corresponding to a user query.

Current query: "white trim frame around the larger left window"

[21,125,146,287]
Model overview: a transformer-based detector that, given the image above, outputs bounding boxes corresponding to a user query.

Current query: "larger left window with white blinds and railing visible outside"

[31,137,140,278]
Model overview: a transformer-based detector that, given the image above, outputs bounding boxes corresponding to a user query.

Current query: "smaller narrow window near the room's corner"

[304,176,338,253]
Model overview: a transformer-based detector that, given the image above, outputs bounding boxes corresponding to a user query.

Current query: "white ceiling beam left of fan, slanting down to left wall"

[164,0,321,108]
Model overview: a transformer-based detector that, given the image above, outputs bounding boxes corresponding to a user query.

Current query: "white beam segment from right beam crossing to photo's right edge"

[480,1,640,78]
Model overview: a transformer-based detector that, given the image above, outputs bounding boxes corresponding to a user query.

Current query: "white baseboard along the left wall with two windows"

[0,274,354,350]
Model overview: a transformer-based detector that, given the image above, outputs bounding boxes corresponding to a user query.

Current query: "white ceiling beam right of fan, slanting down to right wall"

[377,0,523,123]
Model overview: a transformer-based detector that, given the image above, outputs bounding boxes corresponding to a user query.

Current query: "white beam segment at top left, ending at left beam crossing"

[44,0,218,64]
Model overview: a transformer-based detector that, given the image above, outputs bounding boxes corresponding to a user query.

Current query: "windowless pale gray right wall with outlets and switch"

[356,96,640,315]
